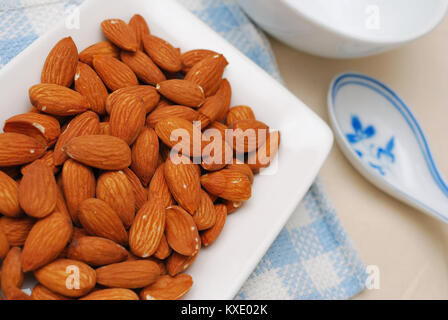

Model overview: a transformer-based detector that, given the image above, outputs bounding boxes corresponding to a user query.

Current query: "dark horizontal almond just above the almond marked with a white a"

[67,237,128,267]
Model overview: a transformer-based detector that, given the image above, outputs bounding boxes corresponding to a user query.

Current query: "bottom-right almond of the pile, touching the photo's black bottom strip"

[140,274,193,300]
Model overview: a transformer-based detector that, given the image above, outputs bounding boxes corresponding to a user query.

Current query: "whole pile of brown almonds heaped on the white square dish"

[0,15,280,300]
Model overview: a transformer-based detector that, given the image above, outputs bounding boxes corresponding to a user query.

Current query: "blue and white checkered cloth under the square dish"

[0,0,366,299]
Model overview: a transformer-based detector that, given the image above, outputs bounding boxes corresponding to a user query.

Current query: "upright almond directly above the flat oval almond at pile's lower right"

[164,159,201,214]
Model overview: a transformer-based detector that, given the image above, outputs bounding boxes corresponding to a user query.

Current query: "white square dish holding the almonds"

[0,0,333,299]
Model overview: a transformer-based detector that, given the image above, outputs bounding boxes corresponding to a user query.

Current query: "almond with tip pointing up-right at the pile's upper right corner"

[185,54,228,97]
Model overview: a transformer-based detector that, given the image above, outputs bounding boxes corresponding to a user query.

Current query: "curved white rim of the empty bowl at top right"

[280,0,448,45]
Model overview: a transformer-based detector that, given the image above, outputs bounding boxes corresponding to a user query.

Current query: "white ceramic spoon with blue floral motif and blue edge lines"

[328,73,448,223]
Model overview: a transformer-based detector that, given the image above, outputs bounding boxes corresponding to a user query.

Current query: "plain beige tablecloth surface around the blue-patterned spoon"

[271,17,448,299]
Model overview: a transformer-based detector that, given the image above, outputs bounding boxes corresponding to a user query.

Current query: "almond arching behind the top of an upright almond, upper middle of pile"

[106,85,160,114]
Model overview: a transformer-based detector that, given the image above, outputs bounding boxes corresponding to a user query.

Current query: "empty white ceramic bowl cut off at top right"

[238,0,448,58]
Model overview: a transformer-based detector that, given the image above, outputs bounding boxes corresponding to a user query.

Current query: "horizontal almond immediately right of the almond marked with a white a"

[96,260,160,289]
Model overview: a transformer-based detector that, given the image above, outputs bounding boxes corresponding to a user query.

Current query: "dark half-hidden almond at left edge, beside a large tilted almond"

[0,217,36,246]
